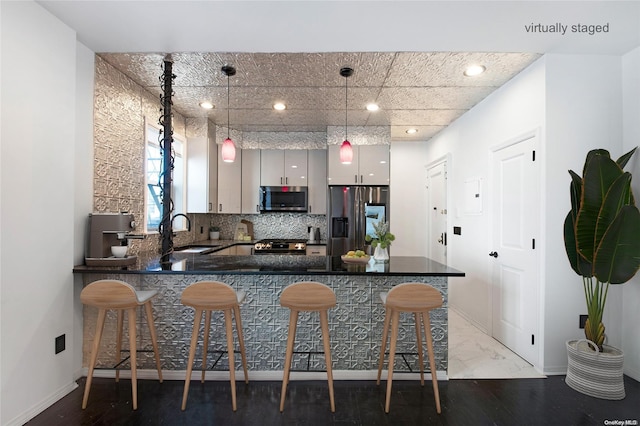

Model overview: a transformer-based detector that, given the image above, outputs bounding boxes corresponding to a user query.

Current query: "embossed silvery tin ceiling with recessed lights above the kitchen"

[99,52,540,141]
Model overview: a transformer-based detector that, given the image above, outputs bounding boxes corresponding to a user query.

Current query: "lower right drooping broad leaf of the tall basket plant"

[594,205,640,284]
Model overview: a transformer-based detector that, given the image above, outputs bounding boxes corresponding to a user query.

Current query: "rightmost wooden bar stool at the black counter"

[376,283,442,414]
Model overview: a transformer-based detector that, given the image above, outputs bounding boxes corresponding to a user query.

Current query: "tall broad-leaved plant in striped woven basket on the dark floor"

[564,148,640,399]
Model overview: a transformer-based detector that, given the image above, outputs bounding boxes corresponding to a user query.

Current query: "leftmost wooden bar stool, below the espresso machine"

[80,280,162,410]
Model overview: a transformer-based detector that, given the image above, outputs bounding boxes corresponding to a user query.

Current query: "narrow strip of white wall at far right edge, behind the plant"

[621,47,640,380]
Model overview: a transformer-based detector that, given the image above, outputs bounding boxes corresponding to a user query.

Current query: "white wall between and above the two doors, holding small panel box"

[427,58,544,340]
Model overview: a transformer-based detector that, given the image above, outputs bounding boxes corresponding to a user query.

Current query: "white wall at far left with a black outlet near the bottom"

[0,2,84,425]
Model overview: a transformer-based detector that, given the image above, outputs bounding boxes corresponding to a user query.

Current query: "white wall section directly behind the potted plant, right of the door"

[544,55,623,374]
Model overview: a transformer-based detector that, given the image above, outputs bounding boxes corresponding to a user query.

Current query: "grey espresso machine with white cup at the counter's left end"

[84,213,144,266]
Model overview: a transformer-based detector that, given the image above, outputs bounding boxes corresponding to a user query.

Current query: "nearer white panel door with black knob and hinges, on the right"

[489,134,540,365]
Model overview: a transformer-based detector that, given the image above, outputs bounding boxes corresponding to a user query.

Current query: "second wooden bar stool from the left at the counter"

[181,281,249,411]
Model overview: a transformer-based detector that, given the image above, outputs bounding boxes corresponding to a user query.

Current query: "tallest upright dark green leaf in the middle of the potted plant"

[575,150,623,263]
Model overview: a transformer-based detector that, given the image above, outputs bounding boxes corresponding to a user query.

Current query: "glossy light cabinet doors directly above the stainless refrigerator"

[327,145,389,185]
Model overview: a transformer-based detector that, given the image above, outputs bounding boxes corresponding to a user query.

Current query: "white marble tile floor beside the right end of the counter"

[448,308,546,379]
